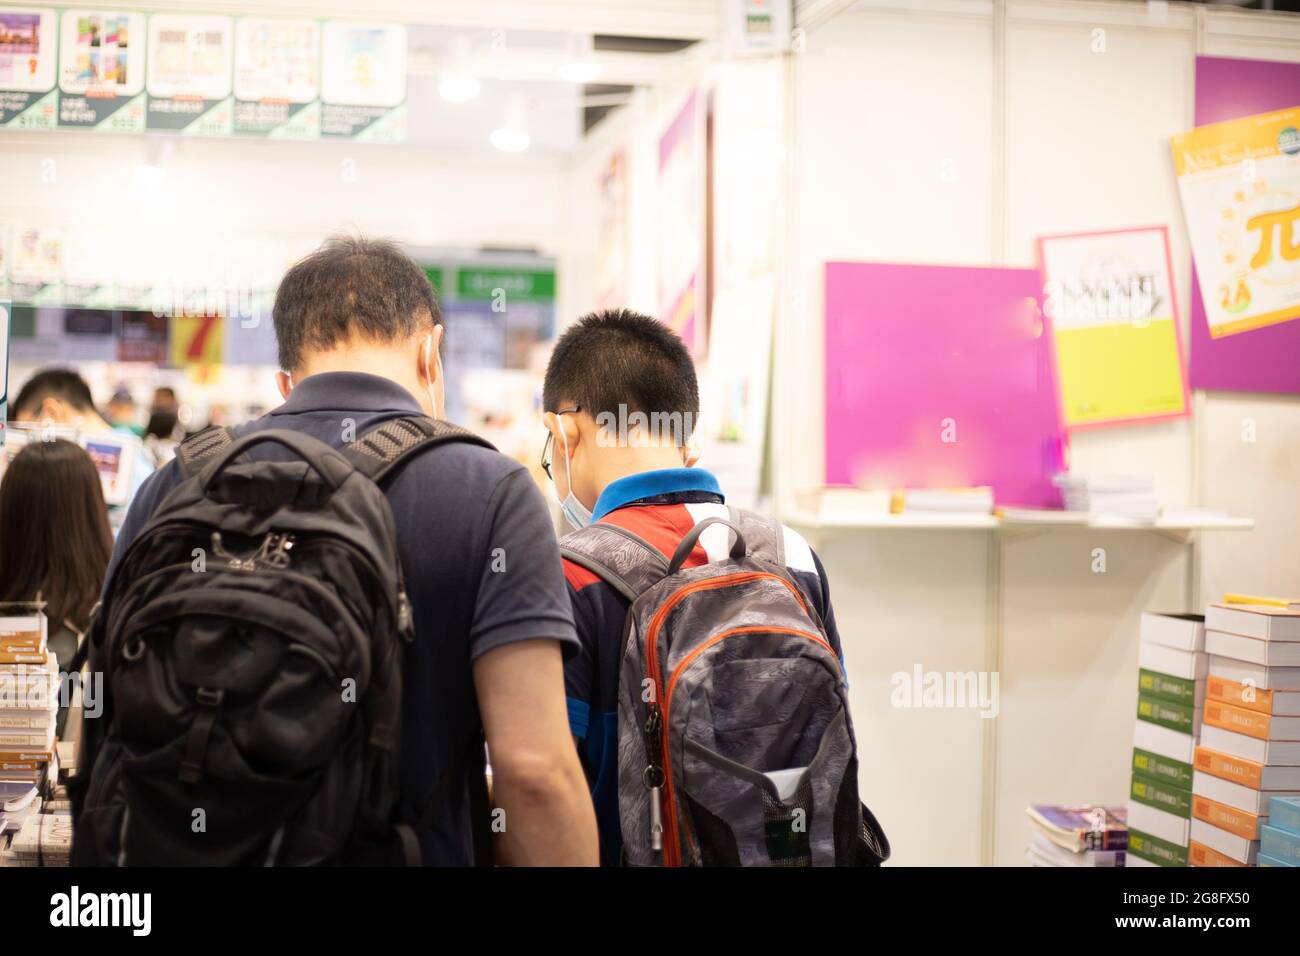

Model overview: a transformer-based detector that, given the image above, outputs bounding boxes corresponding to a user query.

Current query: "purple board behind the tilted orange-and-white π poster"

[1191,56,1300,394]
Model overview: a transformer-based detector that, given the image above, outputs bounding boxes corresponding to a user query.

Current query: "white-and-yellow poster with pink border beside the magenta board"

[1039,226,1188,428]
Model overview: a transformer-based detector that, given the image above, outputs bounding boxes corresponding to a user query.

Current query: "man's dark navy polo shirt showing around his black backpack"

[111,372,579,866]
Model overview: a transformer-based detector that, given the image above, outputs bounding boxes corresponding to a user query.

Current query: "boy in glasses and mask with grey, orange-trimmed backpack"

[542,310,889,866]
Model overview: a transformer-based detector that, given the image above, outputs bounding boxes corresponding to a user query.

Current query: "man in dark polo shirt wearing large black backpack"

[73,238,597,865]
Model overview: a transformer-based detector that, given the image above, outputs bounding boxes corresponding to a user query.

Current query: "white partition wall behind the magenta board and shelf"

[774,0,1300,865]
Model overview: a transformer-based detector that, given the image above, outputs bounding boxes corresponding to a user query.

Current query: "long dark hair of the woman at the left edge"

[0,441,113,734]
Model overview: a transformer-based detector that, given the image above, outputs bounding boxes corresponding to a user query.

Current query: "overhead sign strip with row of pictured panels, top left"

[0,7,407,143]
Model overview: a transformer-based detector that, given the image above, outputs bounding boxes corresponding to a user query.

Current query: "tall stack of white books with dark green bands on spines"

[1126,614,1208,866]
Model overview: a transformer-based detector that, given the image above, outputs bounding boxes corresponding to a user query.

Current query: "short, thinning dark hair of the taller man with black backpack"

[272,235,442,372]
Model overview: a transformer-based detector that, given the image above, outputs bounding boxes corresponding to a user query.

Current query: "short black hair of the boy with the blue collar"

[542,308,699,438]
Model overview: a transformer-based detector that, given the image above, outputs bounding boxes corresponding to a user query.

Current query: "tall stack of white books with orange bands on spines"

[1190,598,1300,866]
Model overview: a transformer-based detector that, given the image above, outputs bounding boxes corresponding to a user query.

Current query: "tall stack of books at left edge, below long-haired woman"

[0,605,60,784]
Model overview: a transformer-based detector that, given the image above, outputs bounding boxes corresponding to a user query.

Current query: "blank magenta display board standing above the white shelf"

[826,263,1067,507]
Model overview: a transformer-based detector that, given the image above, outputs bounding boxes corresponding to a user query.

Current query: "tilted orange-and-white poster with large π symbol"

[1173,107,1300,338]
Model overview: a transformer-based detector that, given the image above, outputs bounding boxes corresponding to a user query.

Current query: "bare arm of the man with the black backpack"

[475,640,599,866]
